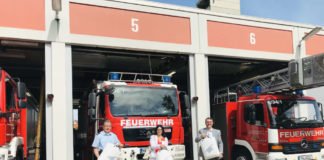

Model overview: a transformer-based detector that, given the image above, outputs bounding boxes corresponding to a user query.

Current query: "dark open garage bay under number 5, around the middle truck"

[72,47,192,160]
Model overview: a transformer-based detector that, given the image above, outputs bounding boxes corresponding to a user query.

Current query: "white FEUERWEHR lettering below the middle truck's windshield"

[120,119,174,127]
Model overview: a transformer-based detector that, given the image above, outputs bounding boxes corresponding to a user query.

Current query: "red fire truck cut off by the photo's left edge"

[0,68,38,160]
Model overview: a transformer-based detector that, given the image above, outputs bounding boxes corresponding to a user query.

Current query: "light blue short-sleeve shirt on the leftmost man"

[92,131,120,150]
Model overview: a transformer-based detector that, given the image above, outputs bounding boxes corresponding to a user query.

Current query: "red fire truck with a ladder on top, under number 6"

[212,56,324,160]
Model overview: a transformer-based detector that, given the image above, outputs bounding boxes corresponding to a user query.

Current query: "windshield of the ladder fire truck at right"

[267,100,323,128]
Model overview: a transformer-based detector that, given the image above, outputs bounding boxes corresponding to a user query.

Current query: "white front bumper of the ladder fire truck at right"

[267,149,324,160]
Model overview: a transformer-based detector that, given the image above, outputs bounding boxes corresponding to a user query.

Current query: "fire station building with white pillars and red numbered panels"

[0,0,324,160]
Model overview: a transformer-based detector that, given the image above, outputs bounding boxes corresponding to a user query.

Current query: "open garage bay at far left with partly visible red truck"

[0,39,46,159]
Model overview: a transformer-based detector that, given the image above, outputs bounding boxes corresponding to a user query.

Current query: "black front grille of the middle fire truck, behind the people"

[123,127,172,142]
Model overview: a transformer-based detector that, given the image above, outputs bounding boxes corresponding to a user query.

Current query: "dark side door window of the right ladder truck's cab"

[244,103,264,125]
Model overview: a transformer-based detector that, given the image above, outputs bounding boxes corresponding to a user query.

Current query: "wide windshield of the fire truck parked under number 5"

[109,86,178,116]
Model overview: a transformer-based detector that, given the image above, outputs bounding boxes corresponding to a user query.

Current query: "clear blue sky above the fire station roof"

[151,0,324,26]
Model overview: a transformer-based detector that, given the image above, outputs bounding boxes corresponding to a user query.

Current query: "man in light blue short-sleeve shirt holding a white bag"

[92,120,123,158]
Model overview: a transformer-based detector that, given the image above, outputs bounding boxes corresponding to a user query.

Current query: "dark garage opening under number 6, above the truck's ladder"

[208,57,288,95]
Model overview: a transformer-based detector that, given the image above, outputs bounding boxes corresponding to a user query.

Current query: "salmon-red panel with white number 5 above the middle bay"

[70,0,191,45]
